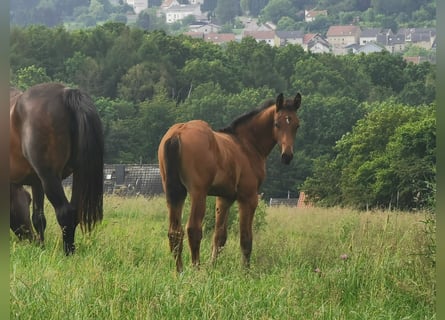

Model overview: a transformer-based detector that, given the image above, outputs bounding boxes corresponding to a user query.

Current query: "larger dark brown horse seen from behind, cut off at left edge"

[9,83,104,255]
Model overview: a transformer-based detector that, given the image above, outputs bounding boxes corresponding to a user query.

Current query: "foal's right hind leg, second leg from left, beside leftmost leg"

[187,192,206,267]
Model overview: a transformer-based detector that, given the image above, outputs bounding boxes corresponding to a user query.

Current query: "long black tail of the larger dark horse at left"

[64,89,104,231]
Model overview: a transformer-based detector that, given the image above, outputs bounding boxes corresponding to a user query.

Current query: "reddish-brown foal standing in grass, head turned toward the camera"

[158,93,301,272]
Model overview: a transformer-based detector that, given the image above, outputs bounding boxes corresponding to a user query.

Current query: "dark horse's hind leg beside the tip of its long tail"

[43,176,78,255]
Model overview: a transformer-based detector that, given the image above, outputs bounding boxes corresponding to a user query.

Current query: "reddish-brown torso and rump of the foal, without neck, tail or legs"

[158,120,255,198]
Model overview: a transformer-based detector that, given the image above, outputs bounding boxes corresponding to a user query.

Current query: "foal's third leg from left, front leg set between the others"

[212,197,233,263]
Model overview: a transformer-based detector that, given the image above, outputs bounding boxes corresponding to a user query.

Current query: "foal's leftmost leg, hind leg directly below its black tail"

[168,199,184,272]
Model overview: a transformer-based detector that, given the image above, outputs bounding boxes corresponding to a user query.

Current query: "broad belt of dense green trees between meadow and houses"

[10,23,435,209]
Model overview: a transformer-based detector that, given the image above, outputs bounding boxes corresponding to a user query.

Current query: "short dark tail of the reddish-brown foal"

[164,136,187,206]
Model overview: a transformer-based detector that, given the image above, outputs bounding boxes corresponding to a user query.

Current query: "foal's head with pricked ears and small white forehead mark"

[274,93,301,164]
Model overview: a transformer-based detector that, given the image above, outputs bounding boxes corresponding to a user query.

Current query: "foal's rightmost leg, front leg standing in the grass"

[239,195,258,267]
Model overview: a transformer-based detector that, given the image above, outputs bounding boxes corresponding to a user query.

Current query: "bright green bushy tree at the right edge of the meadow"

[303,102,435,209]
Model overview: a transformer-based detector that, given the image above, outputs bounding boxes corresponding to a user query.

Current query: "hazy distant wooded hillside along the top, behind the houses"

[10,0,436,32]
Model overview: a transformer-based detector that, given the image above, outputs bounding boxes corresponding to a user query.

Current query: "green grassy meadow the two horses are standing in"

[10,197,436,320]
